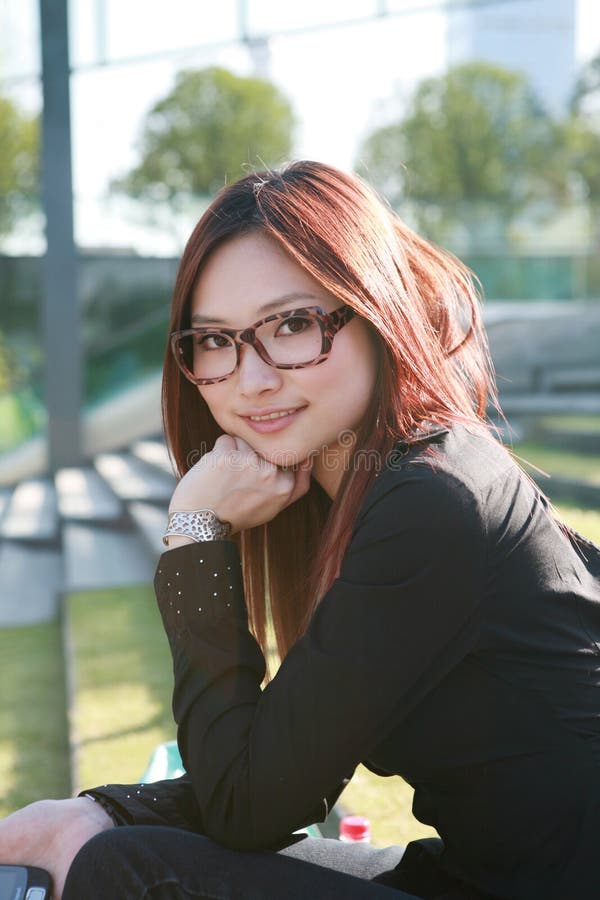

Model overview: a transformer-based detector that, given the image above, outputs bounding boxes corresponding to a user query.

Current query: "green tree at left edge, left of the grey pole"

[0,96,39,234]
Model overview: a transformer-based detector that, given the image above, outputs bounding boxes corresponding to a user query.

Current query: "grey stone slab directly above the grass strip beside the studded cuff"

[63,522,155,591]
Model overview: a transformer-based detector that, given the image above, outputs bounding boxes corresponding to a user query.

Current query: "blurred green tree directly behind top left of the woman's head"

[113,67,294,202]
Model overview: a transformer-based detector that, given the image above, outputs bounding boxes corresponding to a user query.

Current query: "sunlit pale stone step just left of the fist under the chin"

[94,453,175,503]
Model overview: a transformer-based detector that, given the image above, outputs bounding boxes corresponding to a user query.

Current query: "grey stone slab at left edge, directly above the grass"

[0,541,62,626]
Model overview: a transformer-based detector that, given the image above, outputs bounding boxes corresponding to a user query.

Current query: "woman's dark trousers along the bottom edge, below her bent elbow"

[63,826,422,900]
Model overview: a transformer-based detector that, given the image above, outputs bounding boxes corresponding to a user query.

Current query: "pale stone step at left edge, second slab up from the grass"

[0,478,58,541]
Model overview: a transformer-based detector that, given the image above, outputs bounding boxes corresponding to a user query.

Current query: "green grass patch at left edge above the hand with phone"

[0,622,71,818]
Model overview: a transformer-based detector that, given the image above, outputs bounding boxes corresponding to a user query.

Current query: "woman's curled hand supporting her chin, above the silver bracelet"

[169,434,312,532]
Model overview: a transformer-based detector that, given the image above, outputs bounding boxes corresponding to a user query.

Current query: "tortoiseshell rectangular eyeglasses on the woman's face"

[171,303,355,384]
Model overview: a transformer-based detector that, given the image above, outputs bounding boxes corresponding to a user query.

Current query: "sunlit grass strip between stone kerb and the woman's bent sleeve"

[66,585,175,790]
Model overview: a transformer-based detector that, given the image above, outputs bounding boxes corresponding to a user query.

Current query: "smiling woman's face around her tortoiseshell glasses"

[191,231,376,496]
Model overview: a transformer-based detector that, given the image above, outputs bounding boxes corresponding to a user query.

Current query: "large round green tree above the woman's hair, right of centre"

[359,62,560,246]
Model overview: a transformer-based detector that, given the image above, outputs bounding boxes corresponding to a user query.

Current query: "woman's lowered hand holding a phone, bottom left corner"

[0,797,114,900]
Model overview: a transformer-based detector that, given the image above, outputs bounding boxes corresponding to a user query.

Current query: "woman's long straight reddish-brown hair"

[162,161,496,658]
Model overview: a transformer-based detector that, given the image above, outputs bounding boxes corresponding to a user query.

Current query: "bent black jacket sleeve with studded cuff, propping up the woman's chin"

[83,465,485,849]
